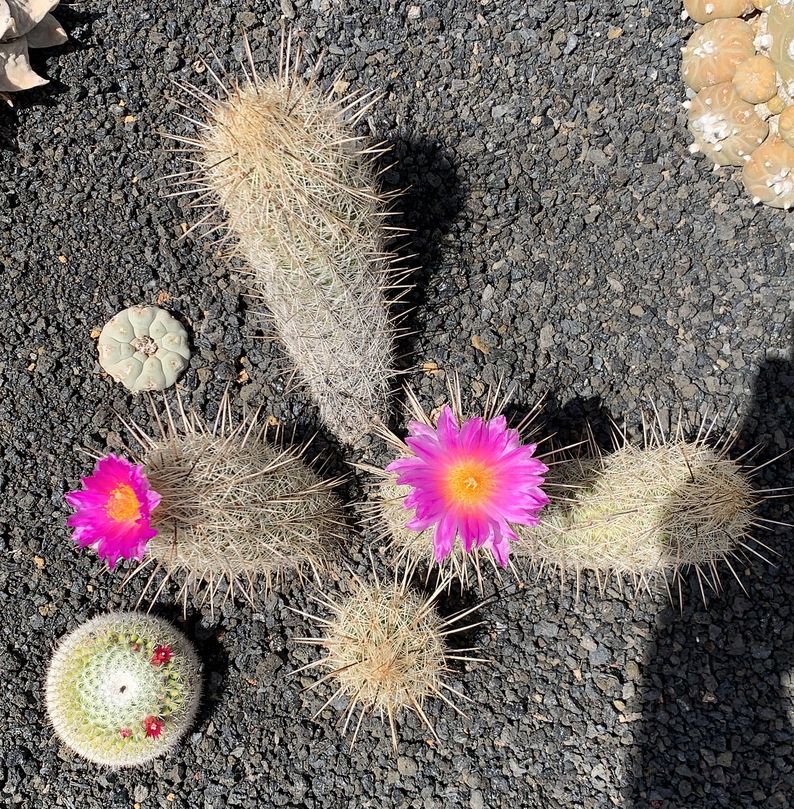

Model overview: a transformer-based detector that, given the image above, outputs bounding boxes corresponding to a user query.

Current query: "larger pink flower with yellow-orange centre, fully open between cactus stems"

[386,406,549,567]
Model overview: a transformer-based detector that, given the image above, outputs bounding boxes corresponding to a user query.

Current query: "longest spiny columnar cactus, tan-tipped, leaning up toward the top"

[165,34,405,443]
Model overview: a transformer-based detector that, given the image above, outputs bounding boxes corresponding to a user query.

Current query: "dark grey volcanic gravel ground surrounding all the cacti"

[0,0,794,809]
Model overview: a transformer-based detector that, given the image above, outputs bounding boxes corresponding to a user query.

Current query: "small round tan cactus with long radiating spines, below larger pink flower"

[288,569,486,751]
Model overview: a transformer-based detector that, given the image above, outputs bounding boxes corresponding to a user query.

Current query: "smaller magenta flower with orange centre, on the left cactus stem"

[66,454,160,570]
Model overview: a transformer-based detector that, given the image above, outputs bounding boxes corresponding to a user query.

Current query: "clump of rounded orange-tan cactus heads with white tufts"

[682,0,794,210]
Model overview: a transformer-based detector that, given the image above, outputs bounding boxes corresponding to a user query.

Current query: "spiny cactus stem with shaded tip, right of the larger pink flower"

[515,414,761,599]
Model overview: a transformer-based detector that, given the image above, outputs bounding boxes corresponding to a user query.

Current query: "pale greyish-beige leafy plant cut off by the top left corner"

[0,0,67,101]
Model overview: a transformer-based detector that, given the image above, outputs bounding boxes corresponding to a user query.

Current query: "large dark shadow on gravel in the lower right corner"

[624,324,794,809]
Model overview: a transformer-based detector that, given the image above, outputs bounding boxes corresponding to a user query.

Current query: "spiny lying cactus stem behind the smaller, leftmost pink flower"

[128,396,343,613]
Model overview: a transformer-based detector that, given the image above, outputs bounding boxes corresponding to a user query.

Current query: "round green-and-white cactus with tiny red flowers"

[46,612,201,768]
